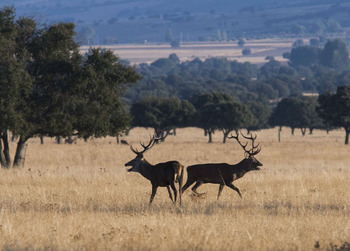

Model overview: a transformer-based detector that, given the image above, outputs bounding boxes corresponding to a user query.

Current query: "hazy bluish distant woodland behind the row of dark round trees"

[125,39,350,104]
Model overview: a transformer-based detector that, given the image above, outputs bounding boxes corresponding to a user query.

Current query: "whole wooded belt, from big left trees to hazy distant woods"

[0,7,350,167]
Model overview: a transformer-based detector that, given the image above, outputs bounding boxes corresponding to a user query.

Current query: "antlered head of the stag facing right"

[228,133,263,171]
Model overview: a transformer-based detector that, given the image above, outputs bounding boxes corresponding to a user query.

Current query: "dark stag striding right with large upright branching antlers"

[182,133,262,199]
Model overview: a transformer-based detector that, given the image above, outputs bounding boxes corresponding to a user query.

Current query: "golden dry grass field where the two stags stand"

[0,128,350,250]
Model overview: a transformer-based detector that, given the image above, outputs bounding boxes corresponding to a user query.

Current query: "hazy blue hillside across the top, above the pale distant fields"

[2,0,350,45]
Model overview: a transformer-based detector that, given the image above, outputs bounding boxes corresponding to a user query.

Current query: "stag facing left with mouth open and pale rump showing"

[125,136,184,205]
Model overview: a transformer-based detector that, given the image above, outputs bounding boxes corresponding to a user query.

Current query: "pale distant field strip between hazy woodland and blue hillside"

[81,38,292,64]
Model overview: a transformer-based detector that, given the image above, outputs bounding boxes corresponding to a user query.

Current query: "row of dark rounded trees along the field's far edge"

[131,89,350,144]
